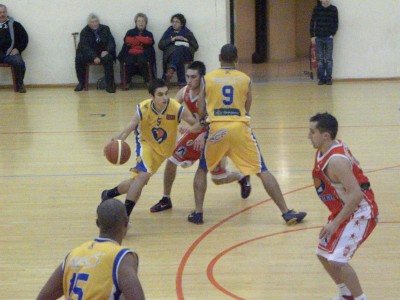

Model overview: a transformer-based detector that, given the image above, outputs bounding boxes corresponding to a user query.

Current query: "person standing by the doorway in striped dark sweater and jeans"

[310,0,339,85]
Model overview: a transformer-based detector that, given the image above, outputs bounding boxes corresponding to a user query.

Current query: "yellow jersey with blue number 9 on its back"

[204,68,251,123]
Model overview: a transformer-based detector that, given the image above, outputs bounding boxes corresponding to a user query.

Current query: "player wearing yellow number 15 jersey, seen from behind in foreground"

[37,199,145,300]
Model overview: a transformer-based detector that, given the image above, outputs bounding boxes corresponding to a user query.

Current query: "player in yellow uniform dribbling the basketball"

[101,79,201,216]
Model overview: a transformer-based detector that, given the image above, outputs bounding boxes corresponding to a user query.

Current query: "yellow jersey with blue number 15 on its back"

[62,238,133,300]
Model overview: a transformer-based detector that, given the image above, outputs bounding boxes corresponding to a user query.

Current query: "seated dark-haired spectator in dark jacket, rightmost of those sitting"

[158,14,199,86]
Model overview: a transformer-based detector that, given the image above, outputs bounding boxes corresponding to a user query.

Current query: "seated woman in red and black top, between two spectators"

[118,13,156,89]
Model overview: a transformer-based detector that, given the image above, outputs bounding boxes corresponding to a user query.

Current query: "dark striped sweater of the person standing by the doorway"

[310,4,339,37]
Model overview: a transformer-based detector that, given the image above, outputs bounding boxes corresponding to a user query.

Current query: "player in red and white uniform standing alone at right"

[308,113,378,300]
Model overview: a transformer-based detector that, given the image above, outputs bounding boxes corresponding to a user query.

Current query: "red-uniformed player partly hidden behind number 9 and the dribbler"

[150,61,251,212]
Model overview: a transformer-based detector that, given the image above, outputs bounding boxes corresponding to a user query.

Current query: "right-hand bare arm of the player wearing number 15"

[118,253,145,300]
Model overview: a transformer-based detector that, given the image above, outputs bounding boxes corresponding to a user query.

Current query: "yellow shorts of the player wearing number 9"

[204,122,267,176]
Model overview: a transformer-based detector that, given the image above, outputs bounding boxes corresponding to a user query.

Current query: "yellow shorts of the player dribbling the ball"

[130,142,169,178]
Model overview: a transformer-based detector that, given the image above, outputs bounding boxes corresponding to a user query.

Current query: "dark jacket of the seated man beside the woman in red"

[76,24,116,60]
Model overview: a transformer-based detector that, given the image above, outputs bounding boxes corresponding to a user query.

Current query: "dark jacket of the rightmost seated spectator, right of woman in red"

[158,26,199,64]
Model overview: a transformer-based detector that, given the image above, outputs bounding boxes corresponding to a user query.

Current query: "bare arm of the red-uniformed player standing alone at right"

[320,156,364,238]
